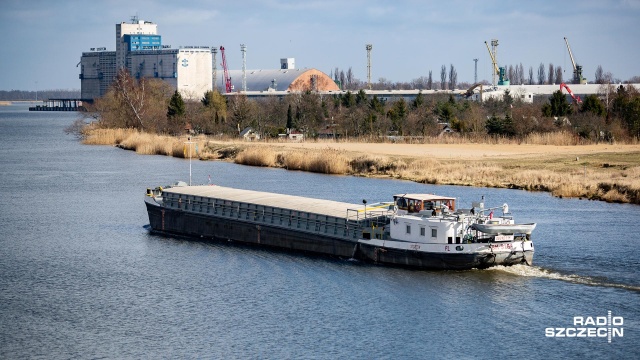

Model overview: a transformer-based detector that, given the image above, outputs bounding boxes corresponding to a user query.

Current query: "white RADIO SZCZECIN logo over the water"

[544,311,624,343]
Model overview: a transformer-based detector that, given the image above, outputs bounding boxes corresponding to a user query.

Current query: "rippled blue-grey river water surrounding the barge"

[0,106,640,359]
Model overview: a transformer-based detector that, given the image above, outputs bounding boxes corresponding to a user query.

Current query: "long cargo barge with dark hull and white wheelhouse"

[145,183,535,269]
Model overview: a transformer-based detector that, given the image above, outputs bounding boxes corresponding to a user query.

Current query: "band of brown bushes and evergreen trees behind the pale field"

[86,71,640,141]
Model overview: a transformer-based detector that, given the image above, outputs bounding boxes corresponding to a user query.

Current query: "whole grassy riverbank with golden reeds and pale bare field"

[83,129,640,204]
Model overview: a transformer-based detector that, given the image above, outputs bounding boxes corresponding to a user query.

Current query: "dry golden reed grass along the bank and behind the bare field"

[83,129,640,204]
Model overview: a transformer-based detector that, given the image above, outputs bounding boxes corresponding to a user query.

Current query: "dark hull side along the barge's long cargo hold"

[146,202,357,258]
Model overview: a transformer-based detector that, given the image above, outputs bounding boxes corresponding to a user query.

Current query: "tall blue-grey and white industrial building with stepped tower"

[79,17,213,100]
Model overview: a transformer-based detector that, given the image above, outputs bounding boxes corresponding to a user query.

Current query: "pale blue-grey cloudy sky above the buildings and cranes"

[0,0,640,90]
